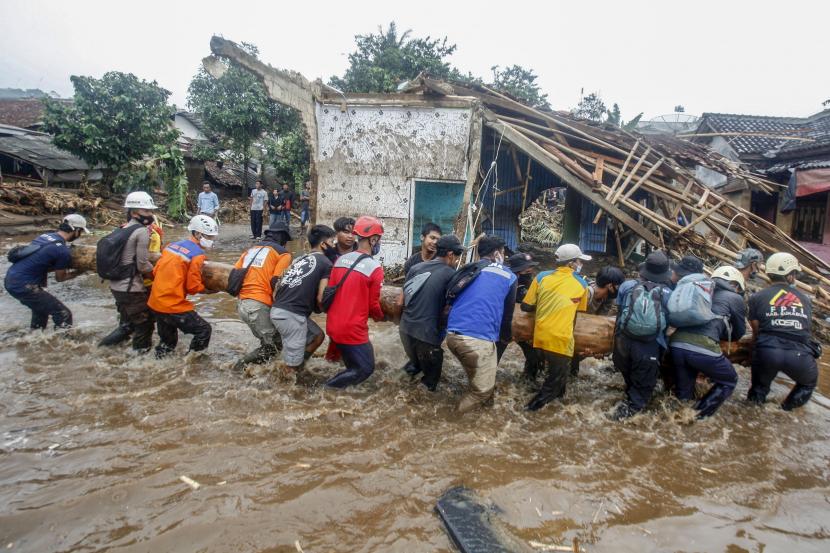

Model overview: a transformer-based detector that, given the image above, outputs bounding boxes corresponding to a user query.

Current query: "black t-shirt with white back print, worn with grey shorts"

[274,252,332,317]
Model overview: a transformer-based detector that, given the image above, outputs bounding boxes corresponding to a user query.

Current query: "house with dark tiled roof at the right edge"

[687,110,830,252]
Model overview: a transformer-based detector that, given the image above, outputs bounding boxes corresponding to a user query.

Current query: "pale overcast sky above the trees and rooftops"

[0,0,830,119]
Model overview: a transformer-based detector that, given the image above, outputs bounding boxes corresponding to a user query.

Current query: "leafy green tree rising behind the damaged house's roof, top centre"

[329,21,460,92]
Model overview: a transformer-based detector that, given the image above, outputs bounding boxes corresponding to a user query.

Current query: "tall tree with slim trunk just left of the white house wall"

[187,42,279,194]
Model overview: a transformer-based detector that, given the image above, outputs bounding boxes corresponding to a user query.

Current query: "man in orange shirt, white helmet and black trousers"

[147,215,219,357]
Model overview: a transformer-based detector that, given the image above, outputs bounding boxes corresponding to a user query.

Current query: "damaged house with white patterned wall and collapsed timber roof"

[204,37,830,314]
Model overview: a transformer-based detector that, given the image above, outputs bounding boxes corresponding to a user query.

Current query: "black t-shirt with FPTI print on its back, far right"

[748,284,813,348]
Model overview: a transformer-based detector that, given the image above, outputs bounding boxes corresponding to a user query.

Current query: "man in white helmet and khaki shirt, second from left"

[98,192,158,352]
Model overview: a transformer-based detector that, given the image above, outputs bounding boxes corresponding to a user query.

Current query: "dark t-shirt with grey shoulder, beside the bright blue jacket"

[400,259,455,346]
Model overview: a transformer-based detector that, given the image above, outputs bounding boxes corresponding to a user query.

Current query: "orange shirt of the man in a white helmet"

[147,240,205,313]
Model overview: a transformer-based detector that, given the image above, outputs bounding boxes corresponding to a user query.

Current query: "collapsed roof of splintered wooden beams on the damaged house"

[206,37,830,309]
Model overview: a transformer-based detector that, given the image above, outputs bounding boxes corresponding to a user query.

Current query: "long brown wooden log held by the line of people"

[72,246,760,362]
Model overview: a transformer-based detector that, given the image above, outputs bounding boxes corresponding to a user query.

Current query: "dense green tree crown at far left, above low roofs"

[44,71,178,172]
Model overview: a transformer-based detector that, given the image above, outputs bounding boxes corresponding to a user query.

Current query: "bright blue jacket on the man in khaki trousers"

[447,262,517,342]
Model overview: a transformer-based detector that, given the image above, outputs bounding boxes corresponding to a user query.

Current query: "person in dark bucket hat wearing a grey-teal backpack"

[611,251,671,420]
